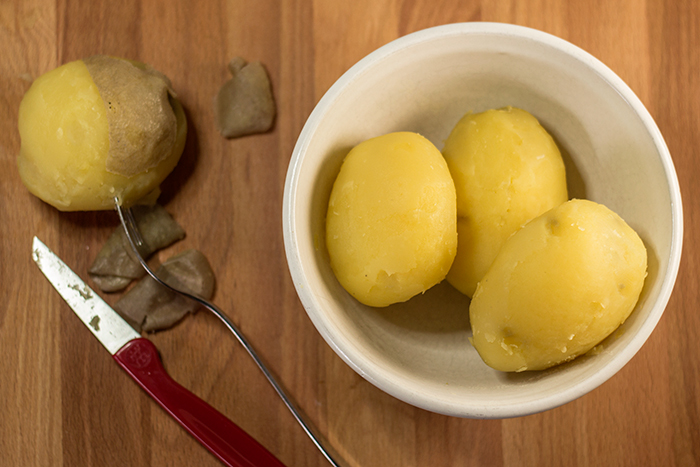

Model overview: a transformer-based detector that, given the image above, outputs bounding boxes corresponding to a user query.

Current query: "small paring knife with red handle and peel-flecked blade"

[32,237,284,467]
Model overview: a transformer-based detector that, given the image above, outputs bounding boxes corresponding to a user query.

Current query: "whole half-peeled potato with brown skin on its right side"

[17,56,187,211]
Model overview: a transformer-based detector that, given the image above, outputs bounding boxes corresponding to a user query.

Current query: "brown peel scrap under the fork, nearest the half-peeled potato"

[88,204,185,292]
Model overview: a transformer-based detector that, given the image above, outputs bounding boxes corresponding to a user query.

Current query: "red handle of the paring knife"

[114,337,284,467]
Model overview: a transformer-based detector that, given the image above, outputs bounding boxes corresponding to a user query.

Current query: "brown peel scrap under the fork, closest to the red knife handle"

[114,250,215,332]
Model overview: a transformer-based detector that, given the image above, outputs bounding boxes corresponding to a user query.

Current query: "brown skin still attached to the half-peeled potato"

[83,55,177,177]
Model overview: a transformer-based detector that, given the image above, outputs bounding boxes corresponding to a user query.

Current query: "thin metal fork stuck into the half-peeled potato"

[114,198,346,467]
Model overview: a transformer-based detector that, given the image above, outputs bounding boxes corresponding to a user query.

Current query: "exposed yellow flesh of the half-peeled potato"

[17,60,187,211]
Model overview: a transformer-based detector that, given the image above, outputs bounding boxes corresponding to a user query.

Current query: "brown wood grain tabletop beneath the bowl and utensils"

[0,0,700,467]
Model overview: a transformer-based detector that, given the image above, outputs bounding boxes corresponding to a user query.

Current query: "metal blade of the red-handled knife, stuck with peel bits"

[32,237,141,355]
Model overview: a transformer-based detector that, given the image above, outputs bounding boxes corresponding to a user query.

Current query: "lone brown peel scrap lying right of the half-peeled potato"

[214,57,276,138]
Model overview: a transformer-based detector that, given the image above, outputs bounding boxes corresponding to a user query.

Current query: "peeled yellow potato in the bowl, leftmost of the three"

[326,132,457,307]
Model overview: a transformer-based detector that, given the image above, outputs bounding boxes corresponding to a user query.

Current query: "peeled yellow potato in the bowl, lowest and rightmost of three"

[469,200,647,371]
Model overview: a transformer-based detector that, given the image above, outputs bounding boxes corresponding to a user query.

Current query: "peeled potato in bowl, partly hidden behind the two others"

[443,107,568,297]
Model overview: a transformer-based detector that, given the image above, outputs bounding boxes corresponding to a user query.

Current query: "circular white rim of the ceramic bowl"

[282,22,683,418]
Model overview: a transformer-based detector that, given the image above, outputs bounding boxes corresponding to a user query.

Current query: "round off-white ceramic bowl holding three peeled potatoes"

[283,23,683,418]
